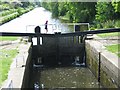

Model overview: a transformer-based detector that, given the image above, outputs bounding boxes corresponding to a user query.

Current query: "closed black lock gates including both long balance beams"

[0,28,120,66]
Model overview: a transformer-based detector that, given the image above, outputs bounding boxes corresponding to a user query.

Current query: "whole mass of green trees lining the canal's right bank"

[42,0,120,29]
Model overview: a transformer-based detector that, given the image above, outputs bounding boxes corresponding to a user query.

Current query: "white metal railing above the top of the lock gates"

[26,23,89,33]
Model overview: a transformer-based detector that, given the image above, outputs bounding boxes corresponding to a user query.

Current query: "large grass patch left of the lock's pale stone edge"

[0,49,18,86]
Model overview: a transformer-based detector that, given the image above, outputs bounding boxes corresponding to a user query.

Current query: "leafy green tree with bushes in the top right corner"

[95,2,120,28]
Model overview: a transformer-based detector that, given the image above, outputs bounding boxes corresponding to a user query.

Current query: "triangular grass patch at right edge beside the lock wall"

[106,44,120,57]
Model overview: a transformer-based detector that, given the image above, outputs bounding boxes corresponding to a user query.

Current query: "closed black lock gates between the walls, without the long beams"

[32,33,85,66]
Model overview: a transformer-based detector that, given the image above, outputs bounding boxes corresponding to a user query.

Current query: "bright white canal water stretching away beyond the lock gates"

[0,7,72,33]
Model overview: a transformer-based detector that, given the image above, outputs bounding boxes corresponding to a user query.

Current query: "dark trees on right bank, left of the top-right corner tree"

[42,2,96,22]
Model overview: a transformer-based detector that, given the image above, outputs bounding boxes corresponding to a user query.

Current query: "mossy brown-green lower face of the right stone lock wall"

[87,51,117,88]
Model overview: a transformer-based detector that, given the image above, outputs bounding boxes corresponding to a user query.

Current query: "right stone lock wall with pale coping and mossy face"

[86,40,120,88]
